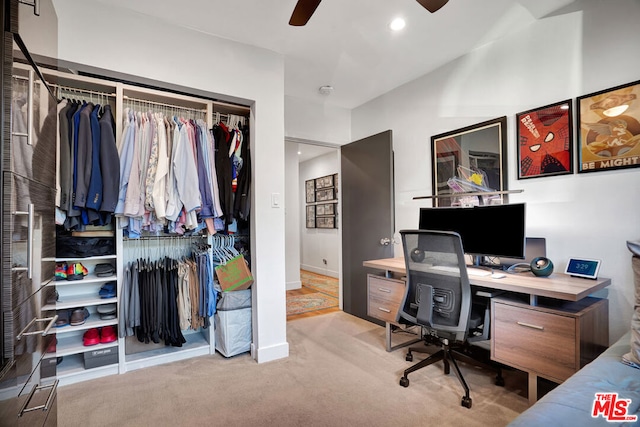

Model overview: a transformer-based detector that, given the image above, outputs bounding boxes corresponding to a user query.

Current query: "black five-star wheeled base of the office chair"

[400,344,504,408]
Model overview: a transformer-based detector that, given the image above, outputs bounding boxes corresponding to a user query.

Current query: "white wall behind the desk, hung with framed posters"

[352,0,640,341]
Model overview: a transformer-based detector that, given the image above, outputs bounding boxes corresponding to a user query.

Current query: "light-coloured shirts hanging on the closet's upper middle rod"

[115,109,232,238]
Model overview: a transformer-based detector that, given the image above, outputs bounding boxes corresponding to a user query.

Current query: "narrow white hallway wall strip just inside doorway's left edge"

[284,142,302,291]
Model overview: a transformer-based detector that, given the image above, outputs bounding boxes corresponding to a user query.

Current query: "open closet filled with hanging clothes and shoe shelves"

[25,63,252,385]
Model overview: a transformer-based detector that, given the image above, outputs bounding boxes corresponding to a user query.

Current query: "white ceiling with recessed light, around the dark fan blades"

[89,0,574,109]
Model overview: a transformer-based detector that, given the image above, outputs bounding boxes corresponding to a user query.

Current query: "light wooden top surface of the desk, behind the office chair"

[362,257,611,301]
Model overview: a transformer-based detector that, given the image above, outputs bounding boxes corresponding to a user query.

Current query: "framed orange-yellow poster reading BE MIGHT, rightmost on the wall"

[577,81,640,173]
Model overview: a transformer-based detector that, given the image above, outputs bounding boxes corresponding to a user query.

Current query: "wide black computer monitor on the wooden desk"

[419,203,525,264]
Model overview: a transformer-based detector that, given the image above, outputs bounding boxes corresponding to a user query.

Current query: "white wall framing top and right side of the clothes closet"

[51,0,289,362]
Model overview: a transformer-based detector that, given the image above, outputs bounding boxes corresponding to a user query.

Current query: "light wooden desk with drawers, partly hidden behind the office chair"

[363,258,611,404]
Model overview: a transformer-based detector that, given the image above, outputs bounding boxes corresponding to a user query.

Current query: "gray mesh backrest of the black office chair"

[397,230,471,341]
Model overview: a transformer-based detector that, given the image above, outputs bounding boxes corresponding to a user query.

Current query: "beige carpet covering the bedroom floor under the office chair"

[58,312,527,427]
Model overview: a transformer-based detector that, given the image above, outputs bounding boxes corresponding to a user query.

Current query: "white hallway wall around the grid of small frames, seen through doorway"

[298,149,341,278]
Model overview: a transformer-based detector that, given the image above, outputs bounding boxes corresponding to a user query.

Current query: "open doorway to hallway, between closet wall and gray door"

[285,140,342,320]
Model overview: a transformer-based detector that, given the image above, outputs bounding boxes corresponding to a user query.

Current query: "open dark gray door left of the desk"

[340,130,395,324]
